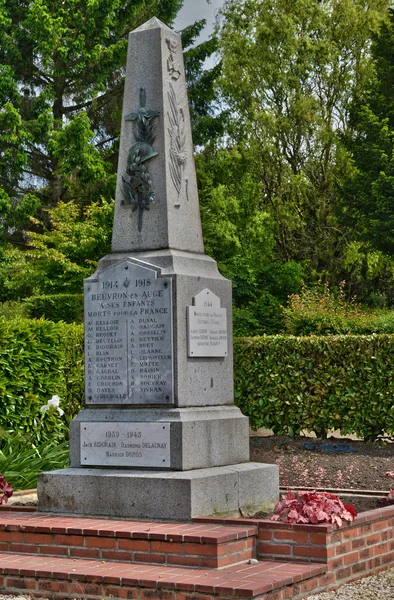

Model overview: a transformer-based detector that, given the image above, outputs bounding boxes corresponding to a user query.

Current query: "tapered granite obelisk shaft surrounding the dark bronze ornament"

[112,18,203,252]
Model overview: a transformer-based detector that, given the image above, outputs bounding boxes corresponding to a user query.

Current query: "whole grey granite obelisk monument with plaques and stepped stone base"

[38,18,278,520]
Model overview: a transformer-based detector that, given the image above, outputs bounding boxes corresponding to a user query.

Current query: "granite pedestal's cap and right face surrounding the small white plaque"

[99,250,234,407]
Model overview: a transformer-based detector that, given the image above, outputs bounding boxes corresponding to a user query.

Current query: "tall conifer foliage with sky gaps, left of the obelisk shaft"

[0,0,182,241]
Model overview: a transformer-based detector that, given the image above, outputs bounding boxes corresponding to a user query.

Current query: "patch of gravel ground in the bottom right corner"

[306,569,394,600]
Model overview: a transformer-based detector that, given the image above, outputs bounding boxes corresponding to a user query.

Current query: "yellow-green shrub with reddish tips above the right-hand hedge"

[283,281,394,335]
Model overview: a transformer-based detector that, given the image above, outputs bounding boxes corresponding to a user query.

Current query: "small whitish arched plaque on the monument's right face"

[187,289,227,356]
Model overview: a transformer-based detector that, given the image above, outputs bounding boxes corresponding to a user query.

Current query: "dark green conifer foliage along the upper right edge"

[343,8,394,256]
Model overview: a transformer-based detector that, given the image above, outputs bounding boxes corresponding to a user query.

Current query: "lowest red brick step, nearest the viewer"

[0,552,328,600]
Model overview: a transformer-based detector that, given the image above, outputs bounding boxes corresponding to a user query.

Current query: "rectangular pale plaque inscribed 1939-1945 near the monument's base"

[81,422,171,467]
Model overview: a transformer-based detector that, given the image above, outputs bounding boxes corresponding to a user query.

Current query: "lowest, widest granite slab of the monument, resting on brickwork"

[38,463,279,521]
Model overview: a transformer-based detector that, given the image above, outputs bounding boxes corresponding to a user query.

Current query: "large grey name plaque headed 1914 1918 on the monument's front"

[85,259,173,405]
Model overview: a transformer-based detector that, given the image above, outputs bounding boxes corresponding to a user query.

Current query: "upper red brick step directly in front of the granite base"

[0,512,257,569]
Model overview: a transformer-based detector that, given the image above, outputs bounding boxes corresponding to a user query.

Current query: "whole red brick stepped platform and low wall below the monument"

[0,506,394,600]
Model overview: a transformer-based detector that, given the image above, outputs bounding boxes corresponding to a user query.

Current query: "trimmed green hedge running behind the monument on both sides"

[0,317,394,441]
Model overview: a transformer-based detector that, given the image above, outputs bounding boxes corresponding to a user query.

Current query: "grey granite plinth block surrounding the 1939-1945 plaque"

[70,406,249,471]
